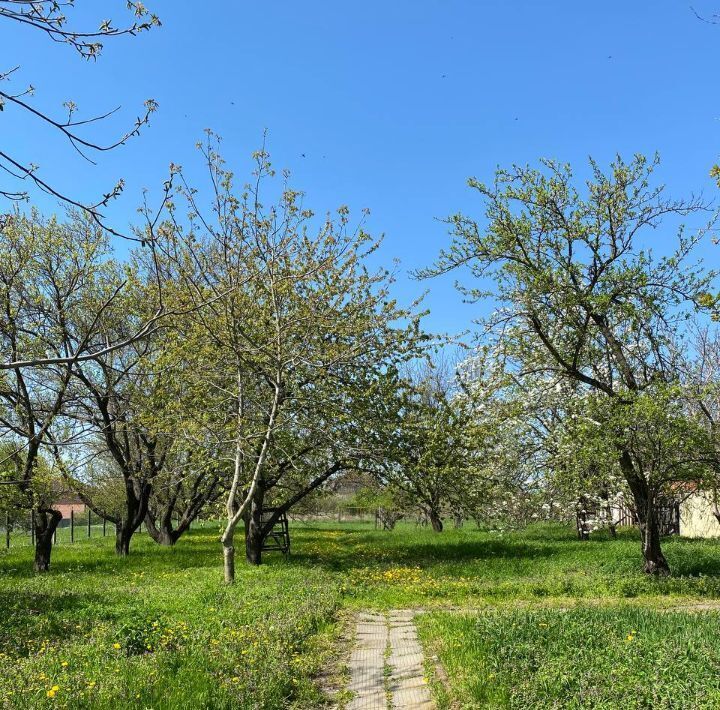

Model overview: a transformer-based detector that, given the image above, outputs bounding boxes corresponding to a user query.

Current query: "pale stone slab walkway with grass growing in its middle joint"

[347,611,435,710]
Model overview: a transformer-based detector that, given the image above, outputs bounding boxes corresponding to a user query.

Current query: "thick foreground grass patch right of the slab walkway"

[417,607,720,710]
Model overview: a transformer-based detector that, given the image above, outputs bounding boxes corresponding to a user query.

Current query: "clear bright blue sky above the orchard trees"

[0,0,720,338]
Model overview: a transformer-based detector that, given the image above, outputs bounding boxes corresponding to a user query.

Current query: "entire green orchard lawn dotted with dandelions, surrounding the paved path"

[0,523,720,710]
